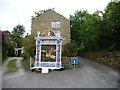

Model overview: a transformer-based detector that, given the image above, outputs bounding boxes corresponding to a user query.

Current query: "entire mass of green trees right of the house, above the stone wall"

[70,1,120,51]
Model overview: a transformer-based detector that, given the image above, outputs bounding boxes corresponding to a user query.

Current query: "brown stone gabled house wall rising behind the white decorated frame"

[31,9,70,44]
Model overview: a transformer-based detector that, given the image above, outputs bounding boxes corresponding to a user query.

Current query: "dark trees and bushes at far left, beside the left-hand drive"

[2,25,25,58]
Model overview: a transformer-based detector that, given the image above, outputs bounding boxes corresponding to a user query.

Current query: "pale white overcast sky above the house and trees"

[0,0,111,33]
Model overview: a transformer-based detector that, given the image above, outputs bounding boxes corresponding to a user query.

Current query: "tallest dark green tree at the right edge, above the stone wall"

[97,2,120,51]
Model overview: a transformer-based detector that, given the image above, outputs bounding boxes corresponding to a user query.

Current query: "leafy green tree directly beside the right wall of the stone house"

[70,11,101,50]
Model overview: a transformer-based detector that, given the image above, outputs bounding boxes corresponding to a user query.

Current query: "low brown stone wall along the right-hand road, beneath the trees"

[81,52,120,69]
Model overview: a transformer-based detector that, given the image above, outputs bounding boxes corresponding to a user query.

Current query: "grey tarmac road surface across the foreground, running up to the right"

[2,58,118,88]
